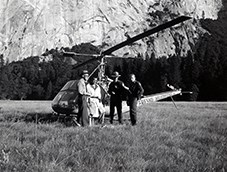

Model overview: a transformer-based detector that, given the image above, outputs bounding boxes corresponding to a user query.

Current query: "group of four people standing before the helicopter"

[77,70,144,126]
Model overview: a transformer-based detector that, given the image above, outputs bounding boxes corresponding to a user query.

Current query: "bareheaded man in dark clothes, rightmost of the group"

[128,74,144,125]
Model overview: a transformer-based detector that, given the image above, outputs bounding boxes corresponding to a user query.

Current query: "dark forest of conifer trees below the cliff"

[0,3,227,101]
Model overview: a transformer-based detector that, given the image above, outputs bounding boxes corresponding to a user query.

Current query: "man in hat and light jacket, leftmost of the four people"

[77,70,90,126]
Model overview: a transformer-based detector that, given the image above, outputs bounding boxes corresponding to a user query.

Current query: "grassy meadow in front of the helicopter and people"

[0,102,227,172]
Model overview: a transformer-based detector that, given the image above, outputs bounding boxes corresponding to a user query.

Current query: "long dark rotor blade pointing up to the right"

[102,16,191,55]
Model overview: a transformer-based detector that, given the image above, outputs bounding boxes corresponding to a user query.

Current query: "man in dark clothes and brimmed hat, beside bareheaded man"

[108,71,129,124]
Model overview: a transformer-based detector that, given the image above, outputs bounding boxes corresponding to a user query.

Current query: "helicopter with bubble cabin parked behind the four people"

[52,16,191,125]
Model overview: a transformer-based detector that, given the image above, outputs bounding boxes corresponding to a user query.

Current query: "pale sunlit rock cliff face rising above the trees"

[0,0,222,61]
